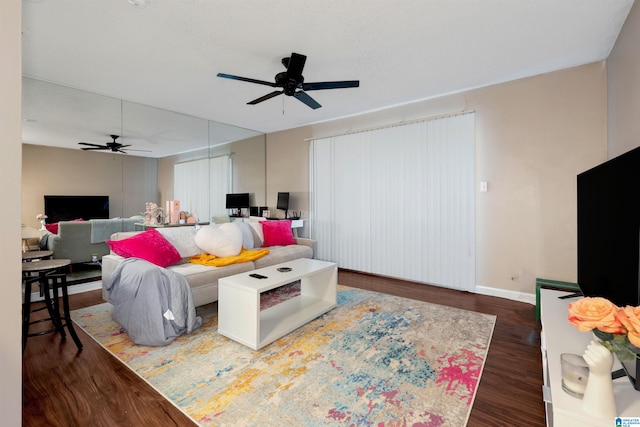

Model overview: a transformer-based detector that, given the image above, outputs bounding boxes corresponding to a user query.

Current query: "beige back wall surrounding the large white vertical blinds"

[267,62,606,293]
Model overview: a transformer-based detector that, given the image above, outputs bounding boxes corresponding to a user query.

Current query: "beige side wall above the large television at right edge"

[607,2,640,158]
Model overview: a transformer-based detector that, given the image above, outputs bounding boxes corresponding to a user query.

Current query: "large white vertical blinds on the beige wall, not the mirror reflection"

[310,113,475,291]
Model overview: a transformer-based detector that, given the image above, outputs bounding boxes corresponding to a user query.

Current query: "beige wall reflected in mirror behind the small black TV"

[22,144,158,228]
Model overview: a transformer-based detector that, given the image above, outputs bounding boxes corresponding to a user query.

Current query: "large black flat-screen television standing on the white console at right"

[577,147,640,390]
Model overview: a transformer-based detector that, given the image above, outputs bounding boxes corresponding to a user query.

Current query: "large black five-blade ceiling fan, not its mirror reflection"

[218,53,360,110]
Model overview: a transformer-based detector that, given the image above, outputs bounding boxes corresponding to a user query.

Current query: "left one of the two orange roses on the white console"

[569,297,626,334]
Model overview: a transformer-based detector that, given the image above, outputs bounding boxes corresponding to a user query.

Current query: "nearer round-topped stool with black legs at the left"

[22,259,82,353]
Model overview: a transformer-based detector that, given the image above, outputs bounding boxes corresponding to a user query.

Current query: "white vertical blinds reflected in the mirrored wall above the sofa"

[173,156,231,221]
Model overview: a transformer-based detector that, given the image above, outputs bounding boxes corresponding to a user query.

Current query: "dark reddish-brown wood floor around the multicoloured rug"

[22,271,545,427]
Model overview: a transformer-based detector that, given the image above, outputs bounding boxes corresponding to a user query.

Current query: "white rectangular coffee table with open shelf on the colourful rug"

[218,258,338,350]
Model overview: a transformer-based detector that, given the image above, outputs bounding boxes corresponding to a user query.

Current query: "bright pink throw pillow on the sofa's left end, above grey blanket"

[107,228,182,267]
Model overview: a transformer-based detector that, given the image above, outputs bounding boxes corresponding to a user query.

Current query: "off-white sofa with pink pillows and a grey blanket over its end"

[102,223,315,306]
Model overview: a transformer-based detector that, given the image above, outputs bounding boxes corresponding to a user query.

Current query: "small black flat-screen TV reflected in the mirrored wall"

[44,195,109,224]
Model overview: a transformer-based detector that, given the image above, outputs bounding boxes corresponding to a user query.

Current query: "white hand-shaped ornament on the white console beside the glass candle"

[582,341,617,421]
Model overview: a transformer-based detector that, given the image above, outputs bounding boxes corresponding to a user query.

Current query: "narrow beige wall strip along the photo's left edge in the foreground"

[0,0,22,427]
